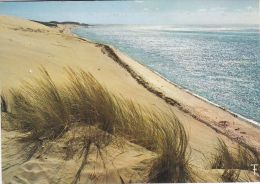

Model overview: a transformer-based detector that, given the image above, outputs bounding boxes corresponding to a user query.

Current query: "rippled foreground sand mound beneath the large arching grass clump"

[2,124,156,184]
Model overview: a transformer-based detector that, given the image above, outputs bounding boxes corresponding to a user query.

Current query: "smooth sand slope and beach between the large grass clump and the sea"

[0,17,260,154]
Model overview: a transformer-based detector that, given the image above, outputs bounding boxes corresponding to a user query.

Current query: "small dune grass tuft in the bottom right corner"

[211,139,260,182]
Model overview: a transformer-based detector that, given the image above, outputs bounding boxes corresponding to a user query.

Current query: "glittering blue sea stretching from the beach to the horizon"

[73,25,260,122]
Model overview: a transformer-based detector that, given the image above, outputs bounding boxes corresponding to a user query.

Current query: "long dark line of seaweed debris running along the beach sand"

[92,42,258,152]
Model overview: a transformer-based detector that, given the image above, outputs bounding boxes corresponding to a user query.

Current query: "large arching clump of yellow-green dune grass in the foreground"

[3,68,192,183]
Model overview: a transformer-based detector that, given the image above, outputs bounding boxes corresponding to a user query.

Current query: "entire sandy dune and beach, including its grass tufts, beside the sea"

[0,16,260,183]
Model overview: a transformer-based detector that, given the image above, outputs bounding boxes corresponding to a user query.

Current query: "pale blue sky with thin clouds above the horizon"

[0,0,260,25]
